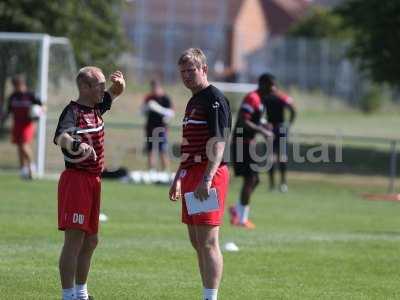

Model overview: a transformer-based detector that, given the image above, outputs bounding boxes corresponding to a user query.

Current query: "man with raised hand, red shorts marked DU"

[54,67,125,300]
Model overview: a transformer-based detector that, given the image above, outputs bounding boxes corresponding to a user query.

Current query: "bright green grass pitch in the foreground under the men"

[0,174,400,300]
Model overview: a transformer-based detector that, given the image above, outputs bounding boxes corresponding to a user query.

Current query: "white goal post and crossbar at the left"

[0,32,76,178]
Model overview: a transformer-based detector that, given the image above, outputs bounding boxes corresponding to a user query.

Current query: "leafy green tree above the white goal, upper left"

[0,0,126,112]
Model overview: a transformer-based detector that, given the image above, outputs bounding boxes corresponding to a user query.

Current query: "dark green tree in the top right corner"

[335,0,400,87]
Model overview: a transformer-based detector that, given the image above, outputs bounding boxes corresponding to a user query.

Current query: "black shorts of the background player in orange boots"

[231,143,259,177]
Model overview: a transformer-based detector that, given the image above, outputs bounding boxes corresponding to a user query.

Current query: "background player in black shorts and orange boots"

[229,74,272,229]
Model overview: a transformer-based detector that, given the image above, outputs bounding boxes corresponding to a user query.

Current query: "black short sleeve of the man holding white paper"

[207,97,232,138]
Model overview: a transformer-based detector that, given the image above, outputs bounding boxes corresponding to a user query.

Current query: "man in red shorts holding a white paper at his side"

[169,48,231,300]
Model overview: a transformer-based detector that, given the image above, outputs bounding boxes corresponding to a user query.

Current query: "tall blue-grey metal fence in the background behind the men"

[123,8,368,105]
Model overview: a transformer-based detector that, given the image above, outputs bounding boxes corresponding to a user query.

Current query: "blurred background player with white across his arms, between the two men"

[142,79,175,171]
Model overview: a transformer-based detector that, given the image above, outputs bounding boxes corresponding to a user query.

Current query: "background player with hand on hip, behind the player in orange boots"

[263,74,296,193]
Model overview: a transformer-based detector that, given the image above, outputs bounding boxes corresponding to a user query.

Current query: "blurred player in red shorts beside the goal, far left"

[1,75,42,179]
